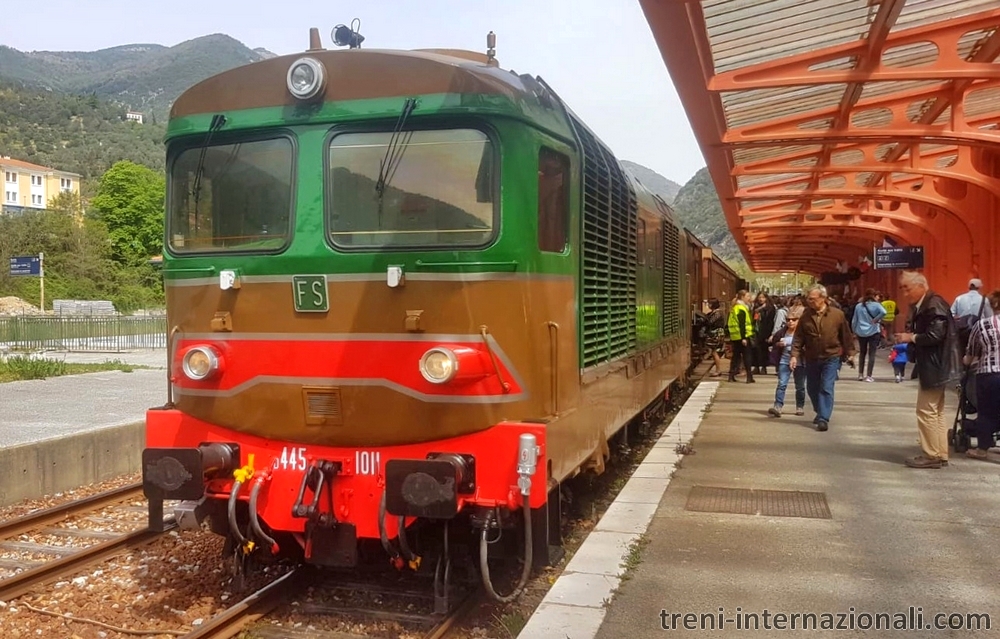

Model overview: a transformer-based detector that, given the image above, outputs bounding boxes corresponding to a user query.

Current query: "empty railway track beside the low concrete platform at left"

[0,484,175,601]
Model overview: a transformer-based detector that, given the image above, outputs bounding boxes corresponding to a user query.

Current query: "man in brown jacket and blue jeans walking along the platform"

[788,284,854,431]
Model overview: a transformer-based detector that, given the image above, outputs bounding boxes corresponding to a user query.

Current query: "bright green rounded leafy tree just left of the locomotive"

[90,160,166,265]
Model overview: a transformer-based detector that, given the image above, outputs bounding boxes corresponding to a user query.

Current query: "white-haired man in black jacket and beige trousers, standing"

[896,271,958,468]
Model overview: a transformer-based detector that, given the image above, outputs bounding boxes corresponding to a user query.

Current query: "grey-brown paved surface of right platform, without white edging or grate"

[584,361,1000,639]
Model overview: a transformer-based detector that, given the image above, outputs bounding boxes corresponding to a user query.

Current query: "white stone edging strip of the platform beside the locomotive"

[517,382,719,639]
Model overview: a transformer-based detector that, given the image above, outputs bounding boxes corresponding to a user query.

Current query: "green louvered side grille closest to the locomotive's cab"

[571,112,637,368]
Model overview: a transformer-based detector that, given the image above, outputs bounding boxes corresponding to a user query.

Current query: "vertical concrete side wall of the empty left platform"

[0,421,146,506]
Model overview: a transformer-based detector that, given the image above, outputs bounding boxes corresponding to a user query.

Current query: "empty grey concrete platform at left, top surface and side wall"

[0,349,167,506]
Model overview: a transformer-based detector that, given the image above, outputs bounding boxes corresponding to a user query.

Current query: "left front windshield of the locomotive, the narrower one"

[167,138,292,253]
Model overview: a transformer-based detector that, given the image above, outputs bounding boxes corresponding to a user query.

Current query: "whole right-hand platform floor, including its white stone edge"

[518,360,1000,639]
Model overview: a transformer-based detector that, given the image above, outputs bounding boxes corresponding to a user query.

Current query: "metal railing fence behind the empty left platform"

[0,315,167,353]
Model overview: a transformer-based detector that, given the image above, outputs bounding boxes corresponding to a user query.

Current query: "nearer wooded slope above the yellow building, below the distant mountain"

[0,82,165,185]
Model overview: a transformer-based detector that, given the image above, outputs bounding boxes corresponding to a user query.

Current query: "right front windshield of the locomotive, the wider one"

[327,129,496,248]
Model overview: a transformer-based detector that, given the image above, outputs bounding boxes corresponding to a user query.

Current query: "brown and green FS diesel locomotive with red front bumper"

[143,30,716,597]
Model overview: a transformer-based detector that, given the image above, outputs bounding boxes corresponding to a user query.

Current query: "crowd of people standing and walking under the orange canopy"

[705,271,1000,468]
